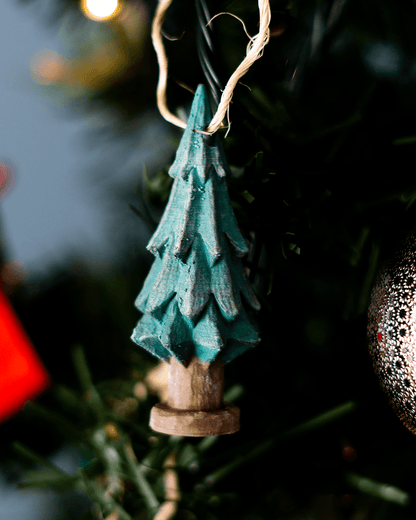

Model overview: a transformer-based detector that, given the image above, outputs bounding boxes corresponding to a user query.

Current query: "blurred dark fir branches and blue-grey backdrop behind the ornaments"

[0,0,416,520]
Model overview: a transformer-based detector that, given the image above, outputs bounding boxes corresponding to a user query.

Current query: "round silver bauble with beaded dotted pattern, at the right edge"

[367,230,416,433]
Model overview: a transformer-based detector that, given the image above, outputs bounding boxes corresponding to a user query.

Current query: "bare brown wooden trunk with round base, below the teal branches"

[150,356,240,437]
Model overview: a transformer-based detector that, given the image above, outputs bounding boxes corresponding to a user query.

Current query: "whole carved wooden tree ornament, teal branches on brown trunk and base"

[131,85,260,437]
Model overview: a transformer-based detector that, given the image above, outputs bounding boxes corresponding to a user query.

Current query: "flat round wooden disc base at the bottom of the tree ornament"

[149,403,240,437]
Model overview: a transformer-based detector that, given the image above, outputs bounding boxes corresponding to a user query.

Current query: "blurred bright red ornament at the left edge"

[0,288,51,421]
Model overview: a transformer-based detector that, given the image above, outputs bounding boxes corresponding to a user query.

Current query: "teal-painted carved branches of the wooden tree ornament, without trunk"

[131,85,260,363]
